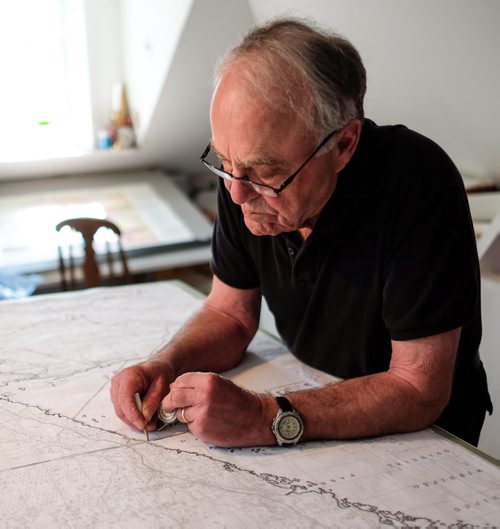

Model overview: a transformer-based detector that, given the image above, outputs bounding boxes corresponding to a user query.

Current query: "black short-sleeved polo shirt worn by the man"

[212,120,491,437]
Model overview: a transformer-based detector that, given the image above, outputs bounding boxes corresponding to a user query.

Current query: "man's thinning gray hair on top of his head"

[215,19,366,138]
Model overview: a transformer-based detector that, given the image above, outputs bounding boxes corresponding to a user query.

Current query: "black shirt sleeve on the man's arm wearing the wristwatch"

[383,138,480,340]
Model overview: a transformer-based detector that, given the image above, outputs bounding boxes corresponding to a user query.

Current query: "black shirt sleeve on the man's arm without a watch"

[211,182,260,289]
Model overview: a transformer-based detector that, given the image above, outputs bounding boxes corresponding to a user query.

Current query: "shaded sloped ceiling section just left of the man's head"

[144,0,253,172]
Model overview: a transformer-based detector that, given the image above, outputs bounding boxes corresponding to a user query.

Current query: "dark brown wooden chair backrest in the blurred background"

[56,218,131,290]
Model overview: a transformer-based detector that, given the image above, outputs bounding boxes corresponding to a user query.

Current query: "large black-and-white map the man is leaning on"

[0,283,500,529]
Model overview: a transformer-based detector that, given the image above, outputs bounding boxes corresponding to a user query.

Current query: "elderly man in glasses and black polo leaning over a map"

[111,20,491,446]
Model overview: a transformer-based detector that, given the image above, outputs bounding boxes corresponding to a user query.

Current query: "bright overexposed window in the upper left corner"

[0,0,93,162]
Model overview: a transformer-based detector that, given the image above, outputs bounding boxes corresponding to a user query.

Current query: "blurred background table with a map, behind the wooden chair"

[0,171,212,291]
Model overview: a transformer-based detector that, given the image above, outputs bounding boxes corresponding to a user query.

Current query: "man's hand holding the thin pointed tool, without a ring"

[110,360,175,430]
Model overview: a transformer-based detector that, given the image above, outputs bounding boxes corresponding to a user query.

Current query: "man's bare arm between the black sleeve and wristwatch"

[264,328,461,440]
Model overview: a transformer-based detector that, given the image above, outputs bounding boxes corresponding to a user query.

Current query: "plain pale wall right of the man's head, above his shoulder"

[249,0,500,183]
